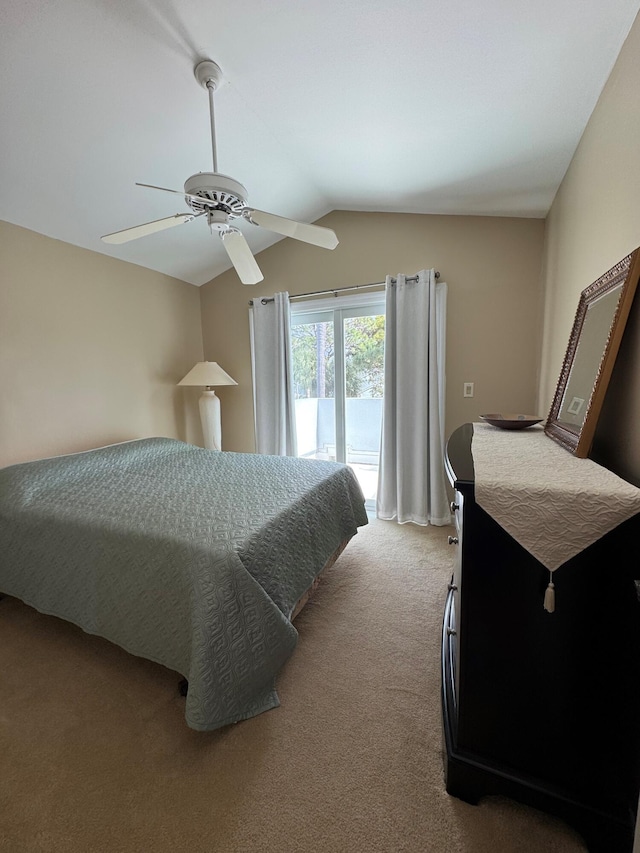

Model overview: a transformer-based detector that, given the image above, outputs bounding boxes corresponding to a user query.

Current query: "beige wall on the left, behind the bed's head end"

[0,223,202,465]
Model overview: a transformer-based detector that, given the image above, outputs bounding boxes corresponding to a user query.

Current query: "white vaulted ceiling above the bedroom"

[0,0,640,285]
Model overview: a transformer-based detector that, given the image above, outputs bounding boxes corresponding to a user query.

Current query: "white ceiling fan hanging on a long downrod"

[102,59,338,284]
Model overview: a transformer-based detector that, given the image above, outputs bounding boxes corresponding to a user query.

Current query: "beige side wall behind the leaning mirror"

[538,11,640,484]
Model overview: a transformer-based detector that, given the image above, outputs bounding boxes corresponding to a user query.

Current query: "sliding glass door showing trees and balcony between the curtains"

[291,294,384,509]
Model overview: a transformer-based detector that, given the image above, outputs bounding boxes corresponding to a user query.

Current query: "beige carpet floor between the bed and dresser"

[0,521,585,853]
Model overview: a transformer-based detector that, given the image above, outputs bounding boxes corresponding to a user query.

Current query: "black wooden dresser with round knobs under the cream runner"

[442,424,640,853]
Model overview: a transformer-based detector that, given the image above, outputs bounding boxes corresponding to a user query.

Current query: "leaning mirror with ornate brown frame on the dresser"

[544,249,640,458]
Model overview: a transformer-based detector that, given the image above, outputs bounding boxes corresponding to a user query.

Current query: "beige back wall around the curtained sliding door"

[201,211,546,451]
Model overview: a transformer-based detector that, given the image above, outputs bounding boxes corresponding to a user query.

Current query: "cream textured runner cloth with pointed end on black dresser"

[471,423,640,572]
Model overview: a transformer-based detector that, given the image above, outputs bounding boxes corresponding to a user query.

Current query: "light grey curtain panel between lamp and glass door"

[250,291,297,456]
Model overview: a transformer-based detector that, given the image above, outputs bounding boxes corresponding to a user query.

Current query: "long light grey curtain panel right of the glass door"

[377,270,451,525]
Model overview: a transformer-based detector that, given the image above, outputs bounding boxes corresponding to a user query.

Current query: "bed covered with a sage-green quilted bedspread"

[0,438,367,731]
